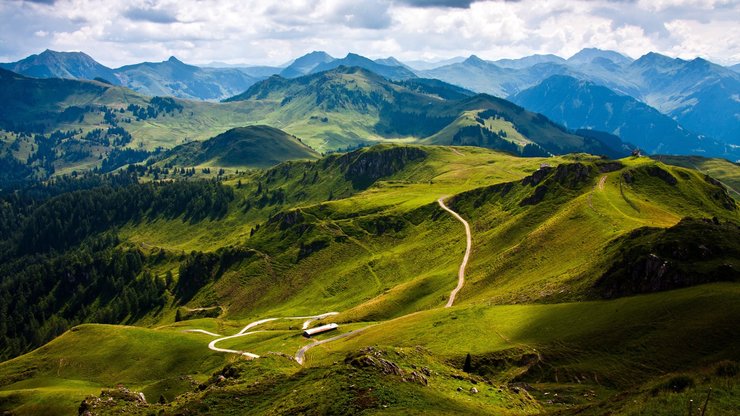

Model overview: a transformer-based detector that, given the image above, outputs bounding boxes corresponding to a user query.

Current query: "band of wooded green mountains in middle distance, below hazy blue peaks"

[0,62,629,183]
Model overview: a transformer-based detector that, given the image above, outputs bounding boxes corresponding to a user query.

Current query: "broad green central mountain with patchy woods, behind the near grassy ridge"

[227,66,625,158]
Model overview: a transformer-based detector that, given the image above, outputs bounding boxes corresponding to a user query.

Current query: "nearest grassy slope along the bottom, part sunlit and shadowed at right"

[0,284,740,414]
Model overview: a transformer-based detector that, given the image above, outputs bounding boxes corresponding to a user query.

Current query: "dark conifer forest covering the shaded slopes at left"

[0,169,234,360]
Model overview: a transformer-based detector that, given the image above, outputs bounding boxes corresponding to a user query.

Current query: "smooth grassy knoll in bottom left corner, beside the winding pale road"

[0,325,228,414]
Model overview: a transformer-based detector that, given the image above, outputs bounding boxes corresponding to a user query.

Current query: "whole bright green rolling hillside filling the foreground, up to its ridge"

[0,145,740,414]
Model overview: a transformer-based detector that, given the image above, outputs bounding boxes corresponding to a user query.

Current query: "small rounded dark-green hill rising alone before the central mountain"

[163,126,319,168]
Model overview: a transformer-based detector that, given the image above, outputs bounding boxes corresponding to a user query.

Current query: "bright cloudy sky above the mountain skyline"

[0,0,740,67]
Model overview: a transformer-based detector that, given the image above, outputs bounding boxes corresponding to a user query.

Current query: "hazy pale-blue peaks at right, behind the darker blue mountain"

[421,49,740,145]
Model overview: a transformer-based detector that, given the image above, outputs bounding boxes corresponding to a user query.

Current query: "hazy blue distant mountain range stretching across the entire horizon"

[0,48,740,155]
